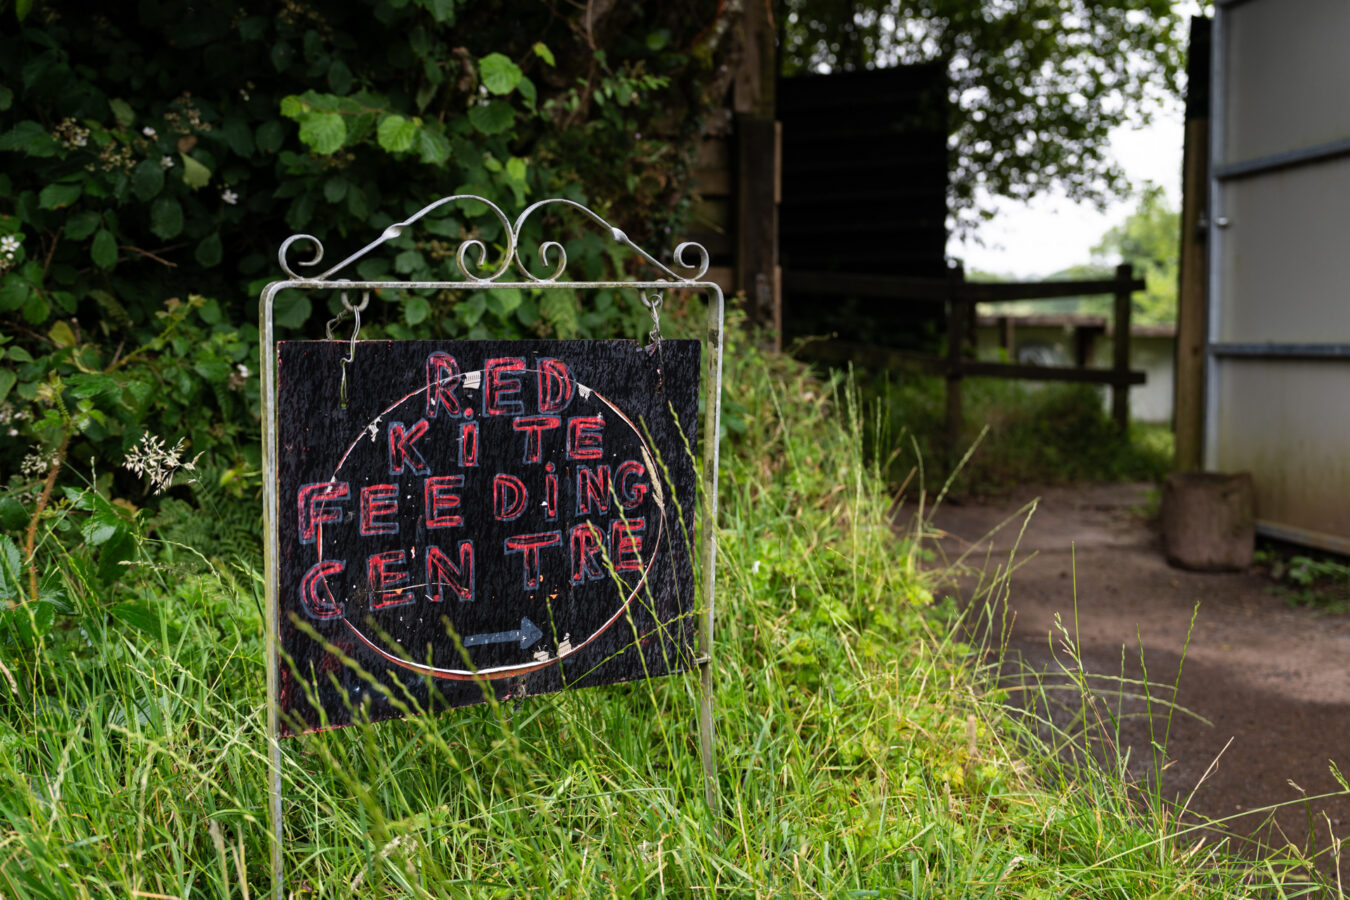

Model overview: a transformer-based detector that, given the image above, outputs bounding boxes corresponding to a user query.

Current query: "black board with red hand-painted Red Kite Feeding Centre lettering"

[274,340,699,734]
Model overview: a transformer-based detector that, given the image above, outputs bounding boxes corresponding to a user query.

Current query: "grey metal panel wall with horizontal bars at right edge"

[1206,0,1350,552]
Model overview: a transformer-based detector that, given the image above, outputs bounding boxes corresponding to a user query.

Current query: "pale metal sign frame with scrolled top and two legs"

[258,194,725,900]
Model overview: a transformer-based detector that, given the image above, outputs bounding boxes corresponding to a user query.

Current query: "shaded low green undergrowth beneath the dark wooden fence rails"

[860,374,1172,495]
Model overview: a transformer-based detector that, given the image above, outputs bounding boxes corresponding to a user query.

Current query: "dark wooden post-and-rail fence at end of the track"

[783,263,1145,449]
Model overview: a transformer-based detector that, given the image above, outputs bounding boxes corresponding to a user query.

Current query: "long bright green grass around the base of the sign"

[0,315,1319,899]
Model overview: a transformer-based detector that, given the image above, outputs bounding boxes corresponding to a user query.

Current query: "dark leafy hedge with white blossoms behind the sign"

[0,0,724,511]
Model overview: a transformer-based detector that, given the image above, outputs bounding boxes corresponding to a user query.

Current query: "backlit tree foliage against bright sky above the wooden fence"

[783,0,1184,228]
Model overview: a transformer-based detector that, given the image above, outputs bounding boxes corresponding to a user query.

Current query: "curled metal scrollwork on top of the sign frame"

[277,194,709,285]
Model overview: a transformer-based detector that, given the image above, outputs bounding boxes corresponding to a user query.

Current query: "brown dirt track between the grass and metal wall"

[932,486,1350,878]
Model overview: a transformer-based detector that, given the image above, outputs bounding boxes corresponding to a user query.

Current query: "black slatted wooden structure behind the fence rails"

[779,63,948,349]
